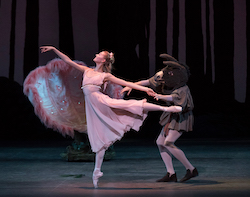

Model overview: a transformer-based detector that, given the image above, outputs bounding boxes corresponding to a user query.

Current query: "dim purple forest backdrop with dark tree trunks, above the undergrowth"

[0,0,250,139]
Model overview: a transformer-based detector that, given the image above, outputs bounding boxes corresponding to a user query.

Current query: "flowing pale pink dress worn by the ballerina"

[82,68,147,152]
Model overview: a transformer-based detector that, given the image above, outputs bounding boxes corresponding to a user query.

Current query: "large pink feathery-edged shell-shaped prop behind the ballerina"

[23,58,122,137]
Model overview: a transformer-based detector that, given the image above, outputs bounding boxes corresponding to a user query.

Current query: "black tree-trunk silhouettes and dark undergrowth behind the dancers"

[0,0,250,142]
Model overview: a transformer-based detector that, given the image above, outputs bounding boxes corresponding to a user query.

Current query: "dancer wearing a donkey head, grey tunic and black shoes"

[122,54,198,182]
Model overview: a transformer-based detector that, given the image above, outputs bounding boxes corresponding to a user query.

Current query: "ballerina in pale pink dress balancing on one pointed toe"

[40,46,182,188]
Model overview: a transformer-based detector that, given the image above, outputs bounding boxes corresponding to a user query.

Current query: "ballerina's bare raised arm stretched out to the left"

[40,46,88,72]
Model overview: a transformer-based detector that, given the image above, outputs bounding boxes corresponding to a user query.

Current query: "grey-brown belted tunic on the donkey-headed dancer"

[149,77,194,132]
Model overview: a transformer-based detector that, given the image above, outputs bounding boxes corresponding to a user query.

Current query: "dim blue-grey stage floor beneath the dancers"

[0,139,250,197]
